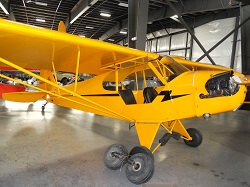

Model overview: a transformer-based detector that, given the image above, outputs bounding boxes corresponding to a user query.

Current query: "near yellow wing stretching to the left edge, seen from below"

[0,19,159,75]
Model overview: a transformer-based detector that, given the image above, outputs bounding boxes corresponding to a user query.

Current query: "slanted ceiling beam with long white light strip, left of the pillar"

[65,0,98,28]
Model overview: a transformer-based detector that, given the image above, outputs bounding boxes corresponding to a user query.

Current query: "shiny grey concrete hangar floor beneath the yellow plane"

[0,100,250,187]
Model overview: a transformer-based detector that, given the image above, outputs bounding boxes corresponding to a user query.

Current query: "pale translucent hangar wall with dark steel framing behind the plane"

[146,18,242,72]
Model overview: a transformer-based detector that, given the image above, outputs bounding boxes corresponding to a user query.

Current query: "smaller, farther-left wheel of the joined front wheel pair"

[103,144,128,170]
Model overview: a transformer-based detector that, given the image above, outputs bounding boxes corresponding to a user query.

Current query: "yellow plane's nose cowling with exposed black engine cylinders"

[195,71,246,117]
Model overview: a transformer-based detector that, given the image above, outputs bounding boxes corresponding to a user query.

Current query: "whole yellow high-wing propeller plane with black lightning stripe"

[0,19,249,184]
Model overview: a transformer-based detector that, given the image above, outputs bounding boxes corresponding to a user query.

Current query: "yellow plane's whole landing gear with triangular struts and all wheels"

[104,120,202,185]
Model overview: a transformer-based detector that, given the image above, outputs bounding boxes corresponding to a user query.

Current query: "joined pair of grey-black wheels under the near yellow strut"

[103,144,154,184]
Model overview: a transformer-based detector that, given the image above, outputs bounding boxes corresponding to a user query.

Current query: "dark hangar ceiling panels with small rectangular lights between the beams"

[0,0,242,43]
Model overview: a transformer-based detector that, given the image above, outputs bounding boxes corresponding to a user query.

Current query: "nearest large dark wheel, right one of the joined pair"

[125,153,154,184]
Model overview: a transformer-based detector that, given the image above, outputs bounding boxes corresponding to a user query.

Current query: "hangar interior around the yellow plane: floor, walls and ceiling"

[0,0,250,186]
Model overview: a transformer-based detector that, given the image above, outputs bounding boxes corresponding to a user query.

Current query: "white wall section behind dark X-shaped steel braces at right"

[192,18,241,72]
